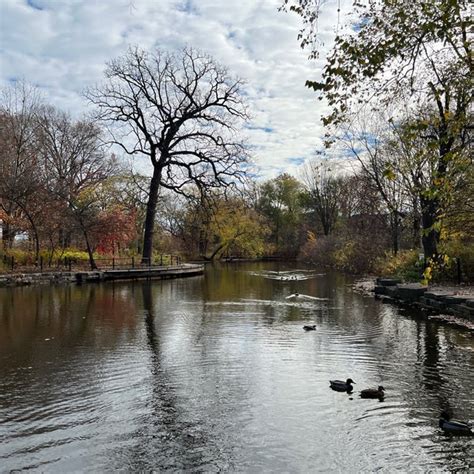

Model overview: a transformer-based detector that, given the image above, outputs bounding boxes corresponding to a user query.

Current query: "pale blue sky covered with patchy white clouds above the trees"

[0,0,348,179]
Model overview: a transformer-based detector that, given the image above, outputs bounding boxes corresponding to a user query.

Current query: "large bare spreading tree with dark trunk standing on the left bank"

[86,48,247,262]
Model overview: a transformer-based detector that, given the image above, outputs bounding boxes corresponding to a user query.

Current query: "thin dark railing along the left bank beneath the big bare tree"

[3,254,181,273]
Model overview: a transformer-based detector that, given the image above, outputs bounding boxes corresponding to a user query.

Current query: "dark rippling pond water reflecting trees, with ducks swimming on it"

[0,264,474,472]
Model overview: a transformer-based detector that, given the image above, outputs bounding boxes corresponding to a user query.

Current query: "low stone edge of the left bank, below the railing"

[0,263,204,287]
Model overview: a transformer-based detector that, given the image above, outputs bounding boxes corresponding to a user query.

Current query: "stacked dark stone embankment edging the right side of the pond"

[374,278,474,322]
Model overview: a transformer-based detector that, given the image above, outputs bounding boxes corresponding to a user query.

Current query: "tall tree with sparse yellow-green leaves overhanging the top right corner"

[284,0,474,258]
